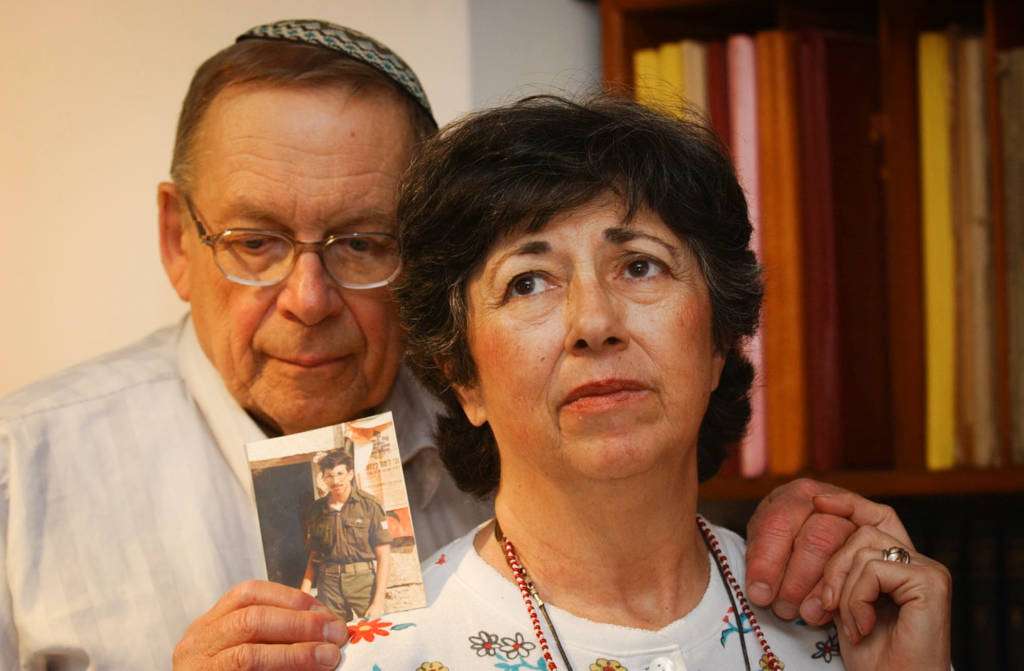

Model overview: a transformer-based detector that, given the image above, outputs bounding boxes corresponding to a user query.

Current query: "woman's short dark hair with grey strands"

[395,96,762,497]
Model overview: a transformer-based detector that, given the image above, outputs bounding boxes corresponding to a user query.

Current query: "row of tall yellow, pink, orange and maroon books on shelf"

[633,28,1024,477]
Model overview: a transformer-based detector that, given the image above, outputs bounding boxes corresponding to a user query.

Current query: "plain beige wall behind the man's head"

[0,0,597,394]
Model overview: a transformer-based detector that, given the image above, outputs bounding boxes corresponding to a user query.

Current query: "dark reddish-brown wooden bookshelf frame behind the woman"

[600,0,1024,499]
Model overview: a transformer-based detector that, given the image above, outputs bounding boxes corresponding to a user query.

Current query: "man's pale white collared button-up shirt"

[0,318,486,669]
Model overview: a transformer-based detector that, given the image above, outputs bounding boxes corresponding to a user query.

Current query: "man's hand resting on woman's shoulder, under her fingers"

[746,478,906,625]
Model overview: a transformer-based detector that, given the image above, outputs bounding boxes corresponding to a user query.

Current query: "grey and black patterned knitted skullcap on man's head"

[236,18,436,123]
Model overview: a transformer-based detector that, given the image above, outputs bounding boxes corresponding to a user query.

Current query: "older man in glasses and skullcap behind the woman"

[0,22,909,669]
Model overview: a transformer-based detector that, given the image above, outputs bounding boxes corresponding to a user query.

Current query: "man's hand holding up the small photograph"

[173,580,348,671]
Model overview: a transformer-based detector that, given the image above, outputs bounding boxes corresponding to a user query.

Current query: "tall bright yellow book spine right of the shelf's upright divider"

[918,32,956,470]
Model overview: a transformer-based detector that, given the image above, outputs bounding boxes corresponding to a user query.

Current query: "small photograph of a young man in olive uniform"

[246,413,425,622]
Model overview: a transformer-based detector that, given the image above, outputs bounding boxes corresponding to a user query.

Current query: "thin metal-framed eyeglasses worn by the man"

[184,196,399,289]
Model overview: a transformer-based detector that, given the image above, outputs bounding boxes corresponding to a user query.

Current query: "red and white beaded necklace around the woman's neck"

[495,515,782,671]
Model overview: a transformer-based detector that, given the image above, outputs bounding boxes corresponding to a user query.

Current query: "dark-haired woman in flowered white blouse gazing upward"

[342,97,949,671]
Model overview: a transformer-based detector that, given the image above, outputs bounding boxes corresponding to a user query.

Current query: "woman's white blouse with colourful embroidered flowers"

[339,527,844,671]
